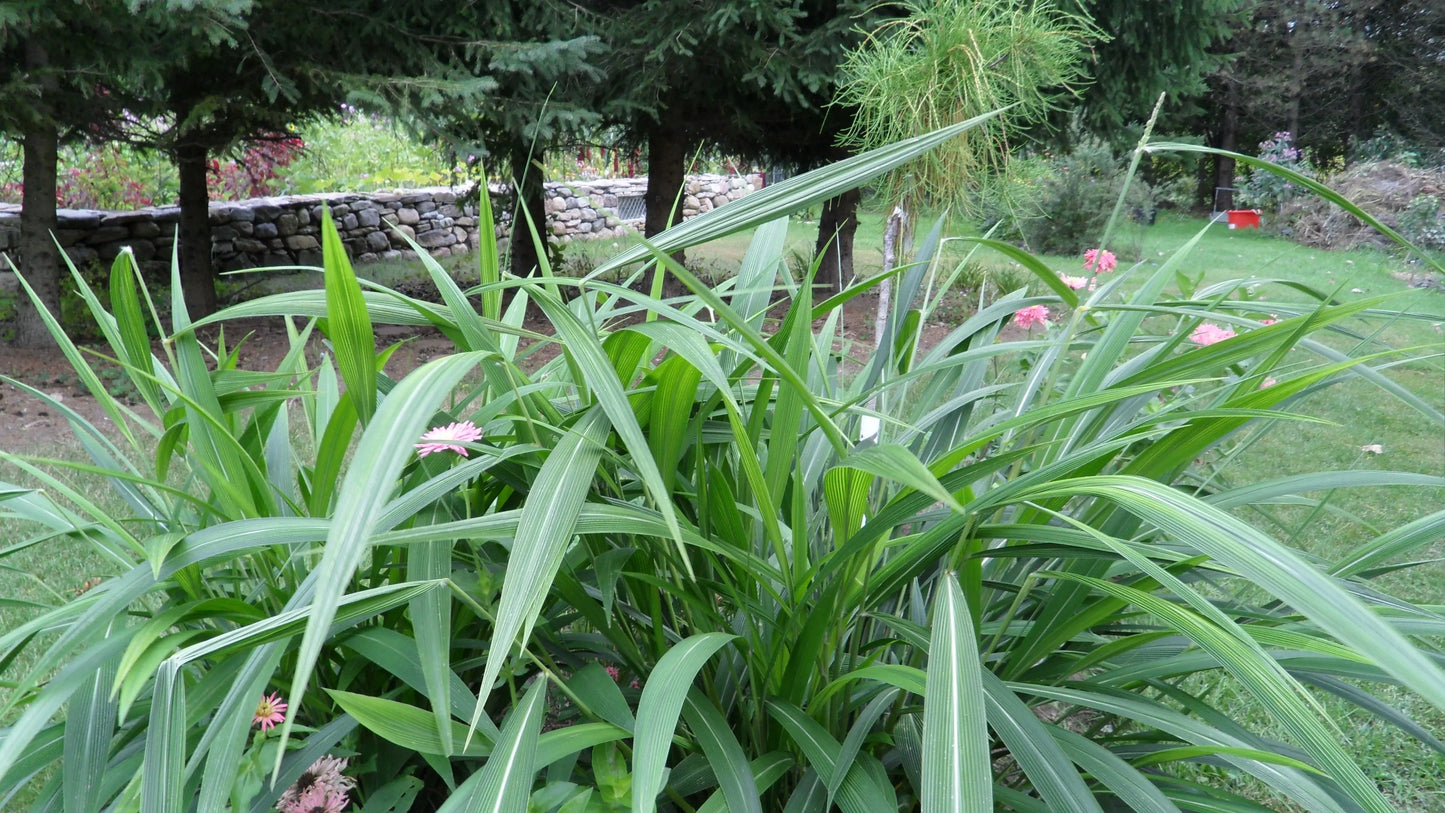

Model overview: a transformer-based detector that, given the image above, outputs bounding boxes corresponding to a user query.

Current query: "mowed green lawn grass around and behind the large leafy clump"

[0,209,1445,813]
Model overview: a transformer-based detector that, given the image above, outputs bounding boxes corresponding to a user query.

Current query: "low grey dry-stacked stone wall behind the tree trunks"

[0,175,762,273]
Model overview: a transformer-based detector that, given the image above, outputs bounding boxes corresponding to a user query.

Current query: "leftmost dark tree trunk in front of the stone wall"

[14,39,61,347]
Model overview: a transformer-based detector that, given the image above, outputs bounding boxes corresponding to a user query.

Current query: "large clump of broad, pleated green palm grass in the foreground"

[0,121,1445,812]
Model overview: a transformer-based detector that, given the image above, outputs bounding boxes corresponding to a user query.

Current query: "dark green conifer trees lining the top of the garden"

[0,0,1445,345]
